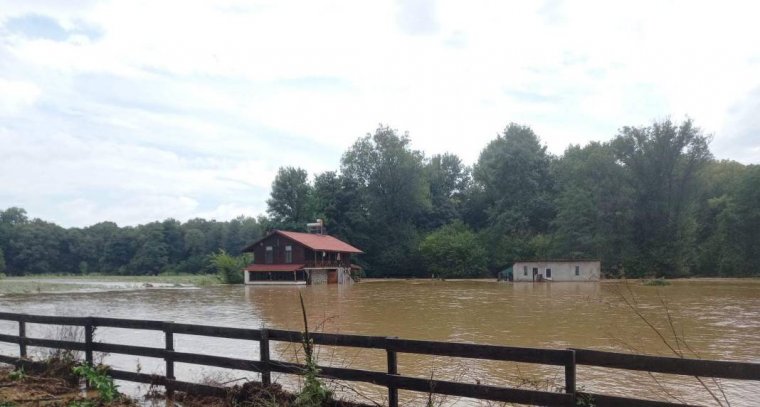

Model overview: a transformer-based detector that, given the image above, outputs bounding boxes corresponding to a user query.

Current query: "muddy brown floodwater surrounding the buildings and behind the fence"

[0,280,760,406]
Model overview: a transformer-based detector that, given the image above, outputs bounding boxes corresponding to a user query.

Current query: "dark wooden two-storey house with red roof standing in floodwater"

[243,221,363,284]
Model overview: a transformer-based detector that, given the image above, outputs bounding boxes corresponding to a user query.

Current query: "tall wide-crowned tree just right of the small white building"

[613,120,711,276]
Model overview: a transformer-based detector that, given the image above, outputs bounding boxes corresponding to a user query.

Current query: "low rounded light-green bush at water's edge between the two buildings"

[420,222,486,278]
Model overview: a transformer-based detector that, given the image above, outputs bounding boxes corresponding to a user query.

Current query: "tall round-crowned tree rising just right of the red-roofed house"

[341,126,430,275]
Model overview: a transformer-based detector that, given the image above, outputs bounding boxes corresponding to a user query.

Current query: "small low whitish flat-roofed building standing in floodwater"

[512,260,602,281]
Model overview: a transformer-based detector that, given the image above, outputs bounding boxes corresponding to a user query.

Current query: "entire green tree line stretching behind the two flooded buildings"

[0,120,760,277]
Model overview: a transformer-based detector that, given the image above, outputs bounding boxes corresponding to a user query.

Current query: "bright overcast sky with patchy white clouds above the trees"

[0,0,760,226]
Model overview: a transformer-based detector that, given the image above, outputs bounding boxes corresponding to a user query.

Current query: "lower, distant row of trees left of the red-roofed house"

[0,208,264,276]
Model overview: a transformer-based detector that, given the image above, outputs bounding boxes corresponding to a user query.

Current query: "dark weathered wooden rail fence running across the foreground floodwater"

[0,312,760,407]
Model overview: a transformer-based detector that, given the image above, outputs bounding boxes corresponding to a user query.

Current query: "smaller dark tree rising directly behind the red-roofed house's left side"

[267,167,313,228]
